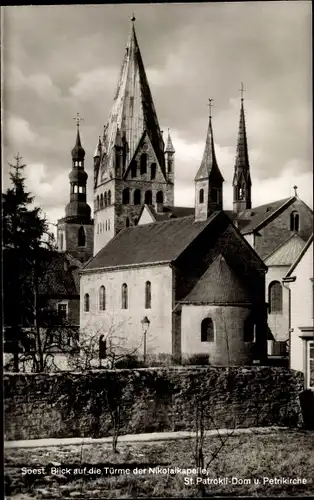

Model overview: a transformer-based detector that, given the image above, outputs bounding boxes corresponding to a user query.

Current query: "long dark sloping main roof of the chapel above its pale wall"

[84,212,221,270]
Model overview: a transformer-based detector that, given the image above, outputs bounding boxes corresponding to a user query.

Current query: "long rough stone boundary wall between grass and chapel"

[4,366,303,440]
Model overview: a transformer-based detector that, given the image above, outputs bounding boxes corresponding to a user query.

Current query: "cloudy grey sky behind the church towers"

[2,1,313,229]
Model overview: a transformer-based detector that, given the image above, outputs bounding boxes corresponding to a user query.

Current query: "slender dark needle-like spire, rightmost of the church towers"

[232,84,252,214]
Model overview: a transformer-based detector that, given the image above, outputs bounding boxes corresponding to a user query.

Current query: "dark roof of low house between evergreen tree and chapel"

[39,252,82,297]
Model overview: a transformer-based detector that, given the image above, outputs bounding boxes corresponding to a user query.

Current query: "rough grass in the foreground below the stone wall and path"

[5,430,314,500]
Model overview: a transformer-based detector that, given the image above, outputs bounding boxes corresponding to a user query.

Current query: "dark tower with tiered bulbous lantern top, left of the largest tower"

[57,113,94,262]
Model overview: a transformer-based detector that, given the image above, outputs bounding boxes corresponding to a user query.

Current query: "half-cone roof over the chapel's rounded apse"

[183,254,250,304]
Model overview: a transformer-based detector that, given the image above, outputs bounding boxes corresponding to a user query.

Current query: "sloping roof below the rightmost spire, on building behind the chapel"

[236,196,295,234]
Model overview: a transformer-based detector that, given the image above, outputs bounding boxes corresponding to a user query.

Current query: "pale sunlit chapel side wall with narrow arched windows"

[80,265,173,357]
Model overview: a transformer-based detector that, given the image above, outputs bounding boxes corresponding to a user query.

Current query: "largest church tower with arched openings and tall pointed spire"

[94,17,174,254]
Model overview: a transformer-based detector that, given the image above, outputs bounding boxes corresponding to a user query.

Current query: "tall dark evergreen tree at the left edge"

[2,154,52,371]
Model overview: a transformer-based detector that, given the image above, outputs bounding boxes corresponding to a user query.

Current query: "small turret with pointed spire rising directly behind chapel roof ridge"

[194,99,224,221]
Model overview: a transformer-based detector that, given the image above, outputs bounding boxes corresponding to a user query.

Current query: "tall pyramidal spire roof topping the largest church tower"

[97,19,165,183]
